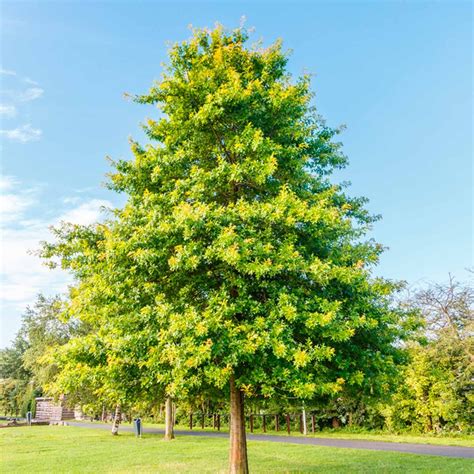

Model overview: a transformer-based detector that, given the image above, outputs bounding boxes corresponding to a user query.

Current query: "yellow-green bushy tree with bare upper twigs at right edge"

[385,276,474,432]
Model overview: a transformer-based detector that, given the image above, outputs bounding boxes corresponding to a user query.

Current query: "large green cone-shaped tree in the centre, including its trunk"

[45,26,414,472]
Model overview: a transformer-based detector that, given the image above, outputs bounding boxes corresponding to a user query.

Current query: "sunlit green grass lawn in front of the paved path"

[0,426,474,474]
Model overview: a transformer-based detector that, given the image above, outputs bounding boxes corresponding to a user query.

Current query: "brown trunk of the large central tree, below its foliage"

[229,376,249,474]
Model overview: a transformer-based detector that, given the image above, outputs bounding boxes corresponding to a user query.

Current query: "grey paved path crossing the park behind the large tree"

[68,421,474,458]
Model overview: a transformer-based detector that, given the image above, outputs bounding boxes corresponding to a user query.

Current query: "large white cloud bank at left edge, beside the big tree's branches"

[0,176,112,346]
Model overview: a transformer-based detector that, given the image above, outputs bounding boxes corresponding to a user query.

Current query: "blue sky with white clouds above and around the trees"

[0,0,473,346]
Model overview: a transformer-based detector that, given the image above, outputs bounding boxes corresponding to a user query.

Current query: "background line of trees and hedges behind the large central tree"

[0,277,474,433]
